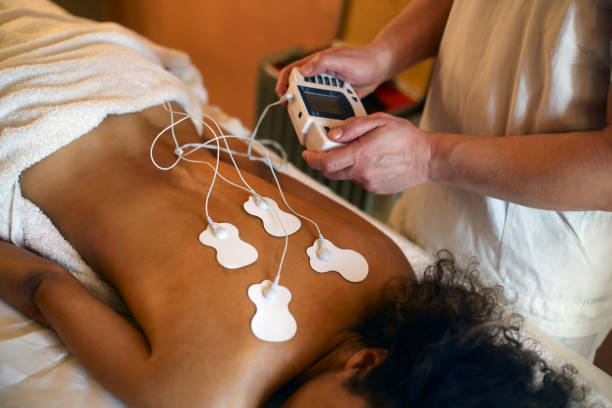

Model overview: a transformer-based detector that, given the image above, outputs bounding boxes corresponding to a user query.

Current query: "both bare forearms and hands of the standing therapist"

[276,0,612,211]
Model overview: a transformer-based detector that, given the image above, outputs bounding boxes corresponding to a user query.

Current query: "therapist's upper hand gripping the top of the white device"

[275,45,388,98]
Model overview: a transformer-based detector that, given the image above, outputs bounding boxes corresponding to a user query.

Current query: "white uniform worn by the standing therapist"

[390,0,612,359]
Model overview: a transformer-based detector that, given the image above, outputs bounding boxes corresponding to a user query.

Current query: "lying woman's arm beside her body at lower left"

[0,241,151,406]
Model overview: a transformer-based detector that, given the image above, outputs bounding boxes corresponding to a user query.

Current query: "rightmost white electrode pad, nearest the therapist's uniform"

[306,239,368,282]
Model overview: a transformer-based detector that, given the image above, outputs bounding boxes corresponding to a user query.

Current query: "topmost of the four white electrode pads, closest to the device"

[243,196,302,237]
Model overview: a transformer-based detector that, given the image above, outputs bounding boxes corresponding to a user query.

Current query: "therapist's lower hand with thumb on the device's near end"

[302,113,433,194]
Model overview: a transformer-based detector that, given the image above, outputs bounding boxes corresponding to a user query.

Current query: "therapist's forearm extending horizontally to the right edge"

[429,127,612,211]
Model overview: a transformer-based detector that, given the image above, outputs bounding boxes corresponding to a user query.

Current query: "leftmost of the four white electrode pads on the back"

[199,222,258,269]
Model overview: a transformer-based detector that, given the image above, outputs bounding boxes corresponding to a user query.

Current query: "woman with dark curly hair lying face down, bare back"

[0,107,574,407]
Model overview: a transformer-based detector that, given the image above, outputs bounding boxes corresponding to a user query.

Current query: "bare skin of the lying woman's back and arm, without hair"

[0,107,414,407]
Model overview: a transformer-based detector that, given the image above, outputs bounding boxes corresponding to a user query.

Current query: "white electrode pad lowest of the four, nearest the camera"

[248,279,297,342]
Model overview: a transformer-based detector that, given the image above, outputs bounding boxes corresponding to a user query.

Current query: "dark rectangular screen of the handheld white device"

[298,86,355,120]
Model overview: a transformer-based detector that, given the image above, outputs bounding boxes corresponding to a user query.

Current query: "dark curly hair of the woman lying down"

[346,251,585,408]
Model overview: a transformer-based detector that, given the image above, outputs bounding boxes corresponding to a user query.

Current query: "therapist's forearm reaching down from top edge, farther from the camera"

[369,0,453,78]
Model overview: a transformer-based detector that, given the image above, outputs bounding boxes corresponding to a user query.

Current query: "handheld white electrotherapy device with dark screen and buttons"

[287,68,366,152]
